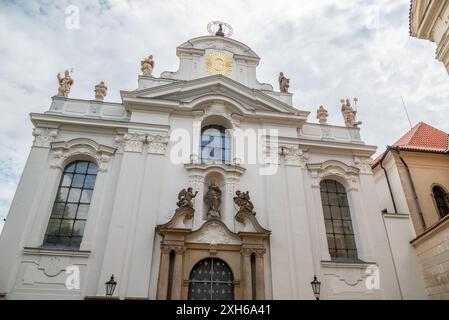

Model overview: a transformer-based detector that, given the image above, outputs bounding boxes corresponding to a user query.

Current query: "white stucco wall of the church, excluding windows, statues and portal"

[0,31,425,299]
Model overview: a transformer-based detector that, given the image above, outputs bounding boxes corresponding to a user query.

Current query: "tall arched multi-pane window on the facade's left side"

[44,161,97,248]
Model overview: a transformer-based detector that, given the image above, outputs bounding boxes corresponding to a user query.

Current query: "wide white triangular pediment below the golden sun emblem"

[121,75,309,123]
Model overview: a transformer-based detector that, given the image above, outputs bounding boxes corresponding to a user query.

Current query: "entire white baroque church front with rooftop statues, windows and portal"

[0,26,425,300]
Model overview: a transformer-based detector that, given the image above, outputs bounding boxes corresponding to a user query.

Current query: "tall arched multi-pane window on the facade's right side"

[320,180,357,259]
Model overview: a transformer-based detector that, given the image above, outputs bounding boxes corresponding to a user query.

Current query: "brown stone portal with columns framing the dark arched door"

[156,208,271,300]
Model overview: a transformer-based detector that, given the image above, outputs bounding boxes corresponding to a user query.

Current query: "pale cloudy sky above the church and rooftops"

[0,0,449,221]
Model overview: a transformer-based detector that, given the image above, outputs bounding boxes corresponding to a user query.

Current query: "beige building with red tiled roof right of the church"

[373,122,449,299]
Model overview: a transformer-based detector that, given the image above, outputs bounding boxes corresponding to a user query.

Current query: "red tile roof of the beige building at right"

[372,122,449,168]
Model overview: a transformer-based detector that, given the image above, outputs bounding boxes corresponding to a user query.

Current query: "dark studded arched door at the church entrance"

[189,258,234,300]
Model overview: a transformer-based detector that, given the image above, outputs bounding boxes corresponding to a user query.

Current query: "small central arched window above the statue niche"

[201,125,231,164]
